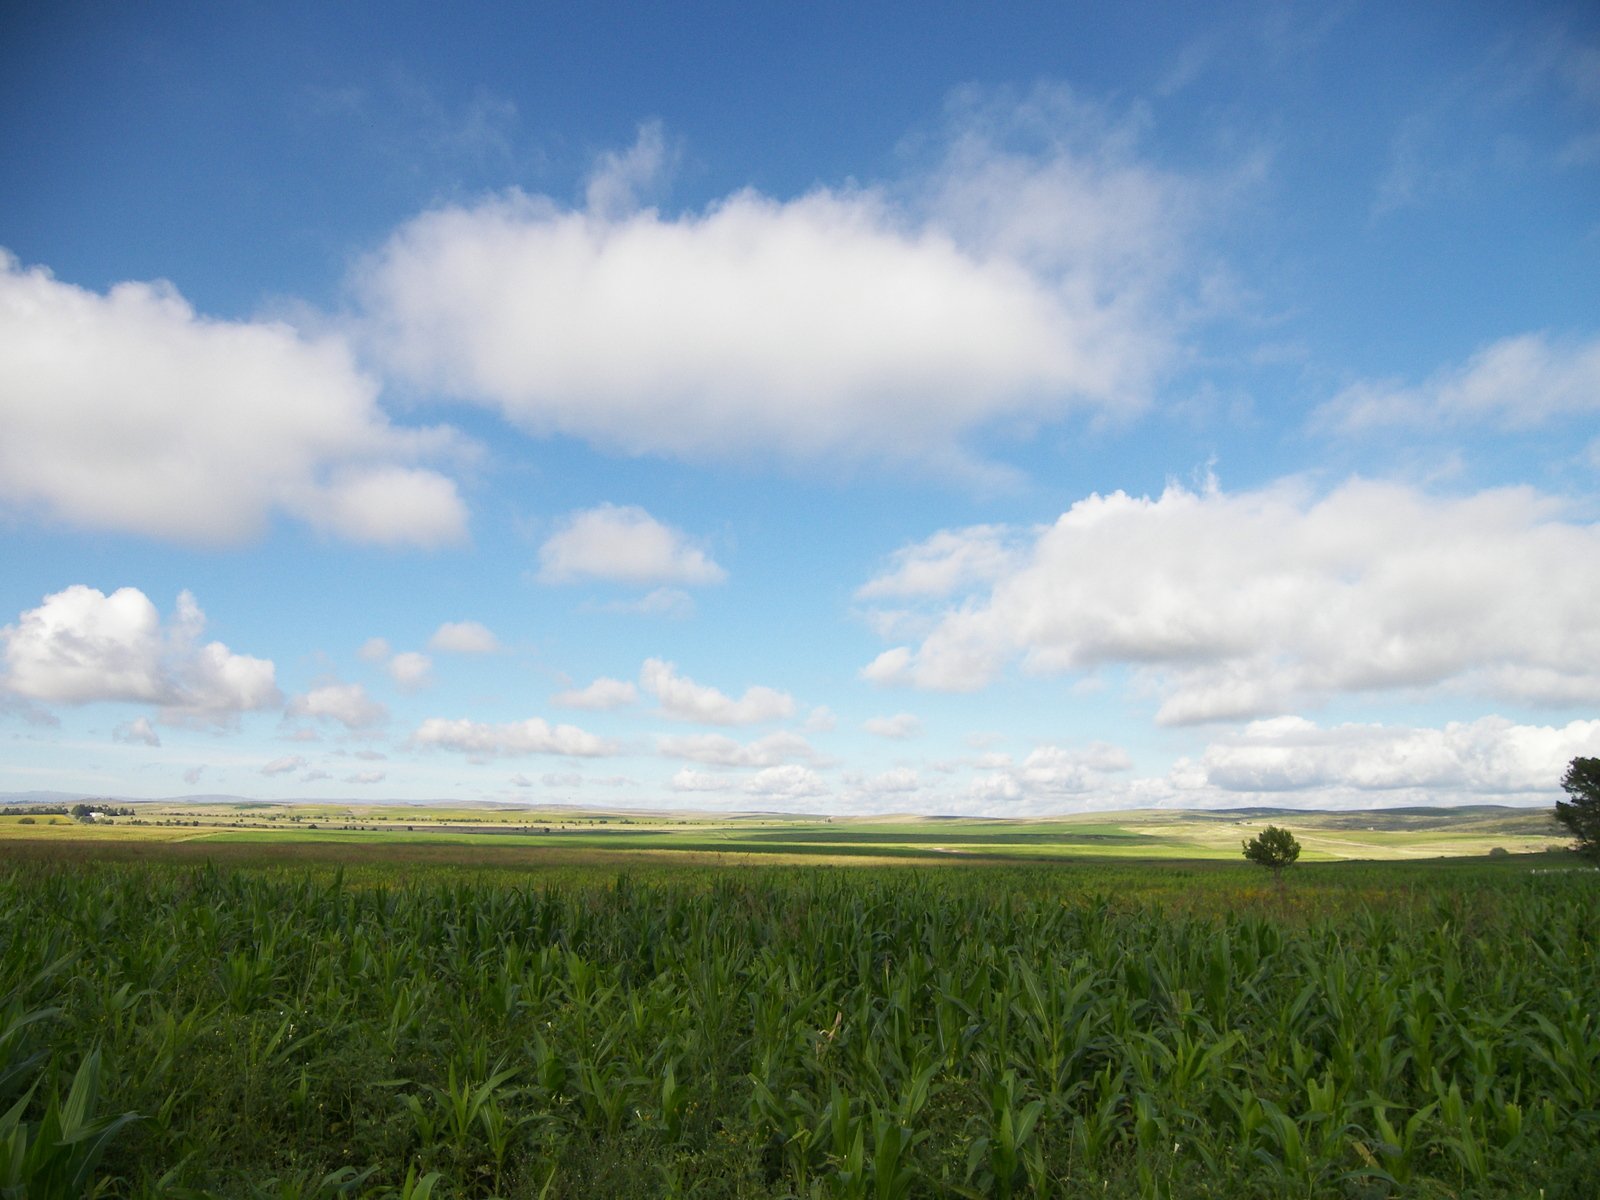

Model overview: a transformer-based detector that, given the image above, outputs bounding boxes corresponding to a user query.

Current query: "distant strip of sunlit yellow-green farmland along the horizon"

[0,803,1568,866]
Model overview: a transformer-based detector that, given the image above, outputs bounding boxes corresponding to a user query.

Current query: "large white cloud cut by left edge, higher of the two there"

[0,250,467,546]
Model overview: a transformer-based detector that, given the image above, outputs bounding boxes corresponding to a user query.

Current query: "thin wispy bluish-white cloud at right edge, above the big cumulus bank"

[1317,333,1600,434]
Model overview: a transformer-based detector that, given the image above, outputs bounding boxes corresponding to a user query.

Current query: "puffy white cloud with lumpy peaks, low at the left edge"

[0,584,282,723]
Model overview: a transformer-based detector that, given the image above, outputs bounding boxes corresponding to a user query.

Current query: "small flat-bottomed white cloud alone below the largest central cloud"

[539,504,728,586]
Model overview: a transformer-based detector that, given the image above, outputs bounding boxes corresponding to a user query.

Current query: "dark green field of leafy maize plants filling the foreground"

[0,846,1600,1200]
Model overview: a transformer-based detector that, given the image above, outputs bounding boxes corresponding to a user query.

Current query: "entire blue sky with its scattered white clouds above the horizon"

[0,3,1600,816]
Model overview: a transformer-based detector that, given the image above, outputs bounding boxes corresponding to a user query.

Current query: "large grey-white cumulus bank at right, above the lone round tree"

[862,480,1600,723]
